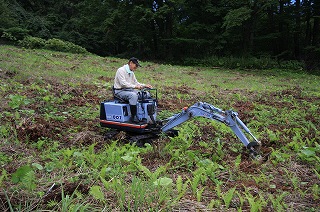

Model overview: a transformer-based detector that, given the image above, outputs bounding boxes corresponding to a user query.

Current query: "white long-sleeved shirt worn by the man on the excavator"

[114,64,144,89]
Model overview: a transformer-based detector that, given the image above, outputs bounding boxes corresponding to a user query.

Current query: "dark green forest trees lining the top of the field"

[0,0,320,70]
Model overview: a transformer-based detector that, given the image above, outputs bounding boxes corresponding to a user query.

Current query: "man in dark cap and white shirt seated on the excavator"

[113,57,152,123]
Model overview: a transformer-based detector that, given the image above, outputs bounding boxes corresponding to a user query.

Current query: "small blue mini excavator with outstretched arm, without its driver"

[100,89,261,157]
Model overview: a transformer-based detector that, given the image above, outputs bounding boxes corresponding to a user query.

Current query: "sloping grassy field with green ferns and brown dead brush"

[0,46,320,211]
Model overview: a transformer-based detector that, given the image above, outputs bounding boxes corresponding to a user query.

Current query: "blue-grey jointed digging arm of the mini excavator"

[161,102,261,156]
